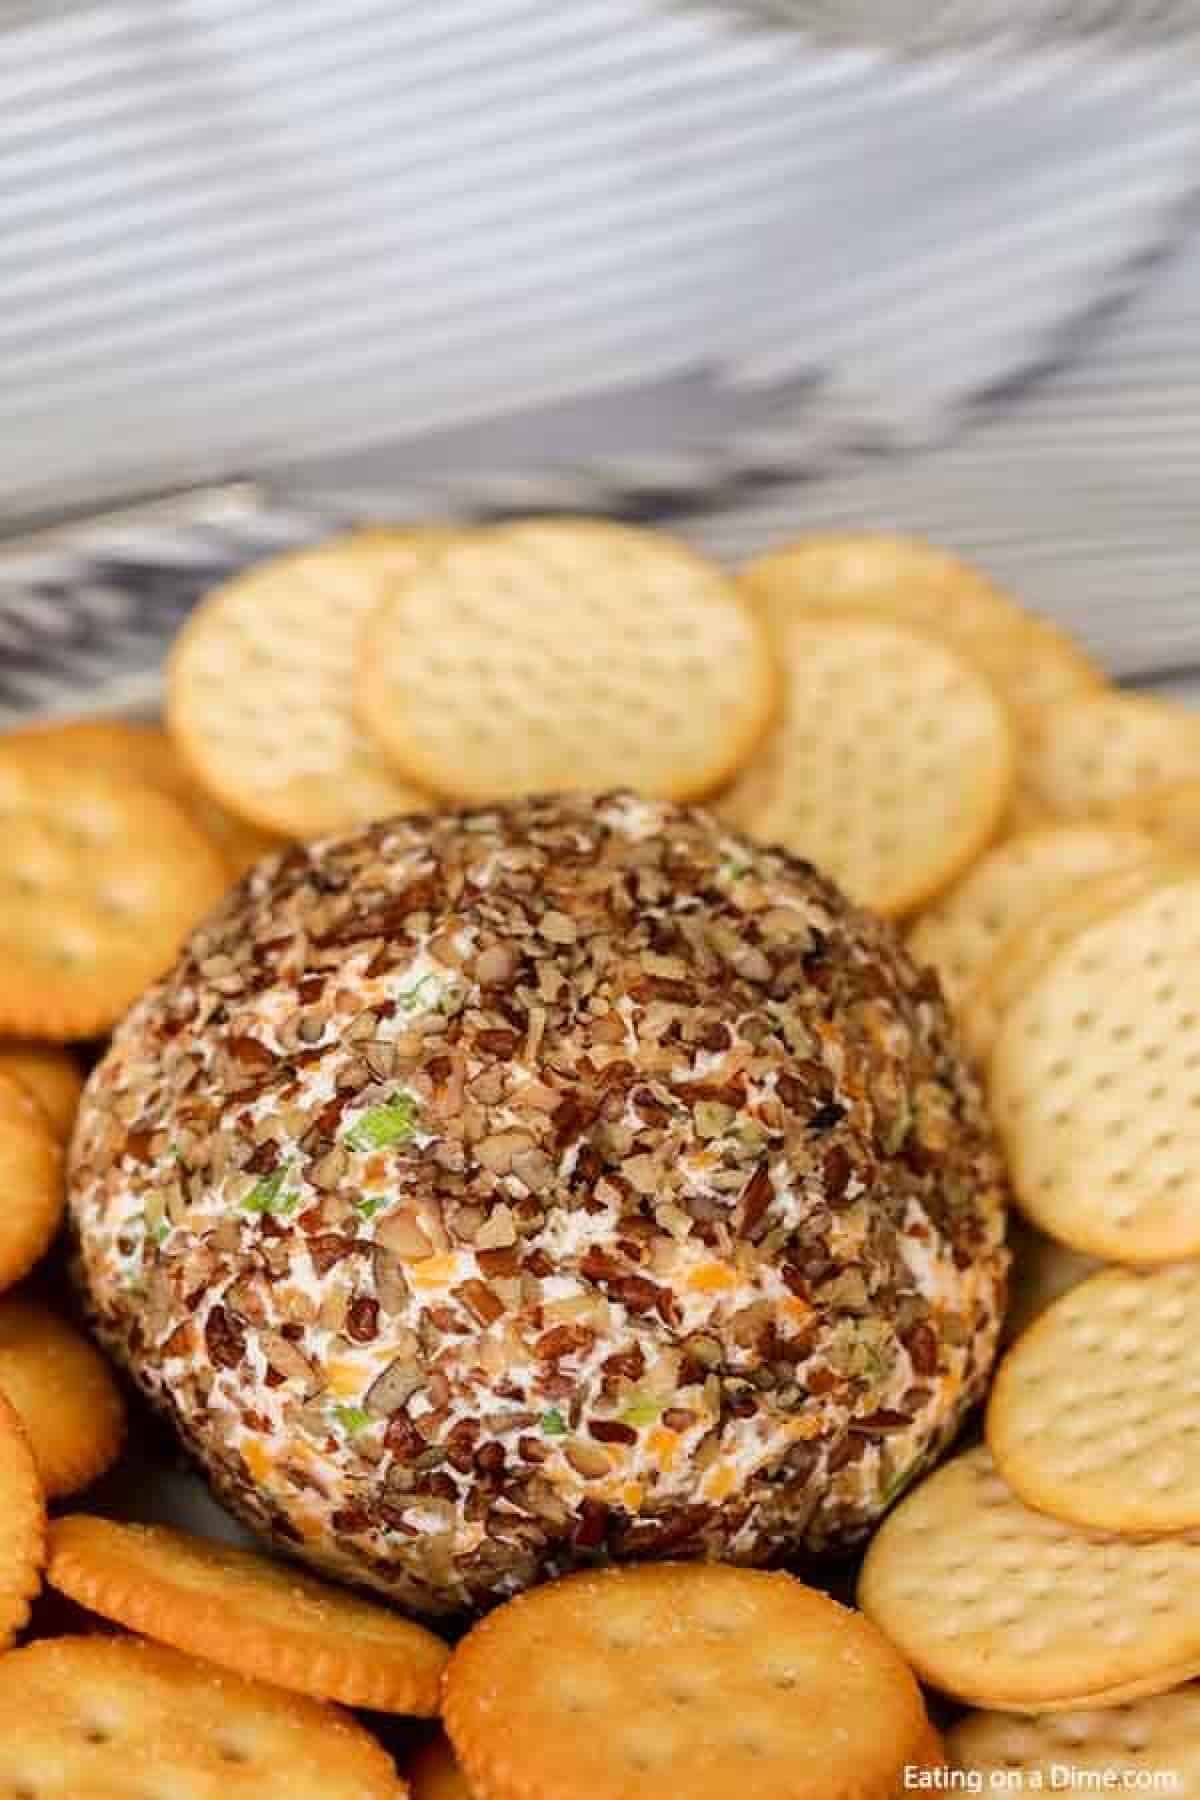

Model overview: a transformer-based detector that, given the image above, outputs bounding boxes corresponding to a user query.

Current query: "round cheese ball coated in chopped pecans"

[70,794,1007,1615]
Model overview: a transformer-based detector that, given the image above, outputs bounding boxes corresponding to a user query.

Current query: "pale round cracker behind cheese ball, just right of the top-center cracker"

[718,612,1013,914]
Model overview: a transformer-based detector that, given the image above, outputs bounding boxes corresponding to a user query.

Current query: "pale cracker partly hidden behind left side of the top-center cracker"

[167,535,437,837]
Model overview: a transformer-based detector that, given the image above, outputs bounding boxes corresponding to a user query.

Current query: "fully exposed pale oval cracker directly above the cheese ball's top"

[358,518,775,801]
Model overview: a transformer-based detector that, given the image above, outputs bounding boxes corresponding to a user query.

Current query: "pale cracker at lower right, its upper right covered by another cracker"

[858,1447,1200,1712]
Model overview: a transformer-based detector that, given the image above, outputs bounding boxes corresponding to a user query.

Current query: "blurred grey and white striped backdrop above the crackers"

[0,0,1200,716]
